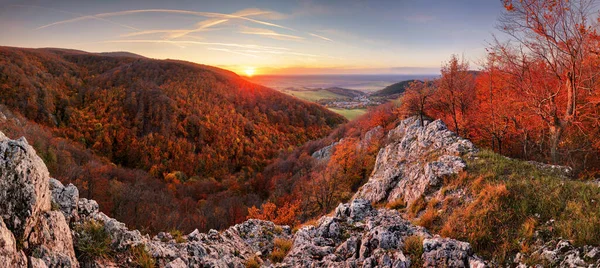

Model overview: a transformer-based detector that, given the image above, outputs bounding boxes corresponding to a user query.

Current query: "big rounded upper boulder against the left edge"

[0,132,50,240]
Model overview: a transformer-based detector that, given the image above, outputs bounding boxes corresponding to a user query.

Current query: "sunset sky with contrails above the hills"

[0,0,503,75]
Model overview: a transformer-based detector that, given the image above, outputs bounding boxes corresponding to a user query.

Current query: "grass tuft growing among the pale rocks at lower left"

[74,220,112,260]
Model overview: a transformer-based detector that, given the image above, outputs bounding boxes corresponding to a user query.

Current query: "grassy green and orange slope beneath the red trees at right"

[434,151,600,263]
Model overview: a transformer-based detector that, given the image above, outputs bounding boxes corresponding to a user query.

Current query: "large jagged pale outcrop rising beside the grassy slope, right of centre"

[354,117,477,205]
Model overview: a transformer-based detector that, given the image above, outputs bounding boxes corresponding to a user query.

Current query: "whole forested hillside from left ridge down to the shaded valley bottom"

[0,47,345,233]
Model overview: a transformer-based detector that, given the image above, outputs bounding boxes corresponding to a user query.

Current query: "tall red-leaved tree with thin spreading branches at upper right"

[498,0,594,163]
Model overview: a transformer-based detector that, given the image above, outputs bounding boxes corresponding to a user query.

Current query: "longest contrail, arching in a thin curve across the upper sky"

[37,9,296,31]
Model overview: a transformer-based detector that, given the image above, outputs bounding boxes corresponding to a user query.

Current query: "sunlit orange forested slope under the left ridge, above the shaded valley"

[0,47,344,179]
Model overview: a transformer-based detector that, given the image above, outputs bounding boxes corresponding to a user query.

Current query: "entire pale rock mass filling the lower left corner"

[0,132,79,267]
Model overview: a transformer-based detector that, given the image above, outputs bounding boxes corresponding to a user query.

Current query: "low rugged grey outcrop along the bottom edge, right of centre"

[279,199,484,267]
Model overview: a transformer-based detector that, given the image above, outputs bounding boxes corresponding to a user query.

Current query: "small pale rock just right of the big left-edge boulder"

[50,178,79,222]
